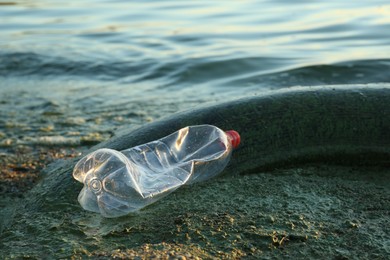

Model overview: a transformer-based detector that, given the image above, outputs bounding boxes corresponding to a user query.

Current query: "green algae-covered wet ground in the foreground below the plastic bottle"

[2,154,390,259]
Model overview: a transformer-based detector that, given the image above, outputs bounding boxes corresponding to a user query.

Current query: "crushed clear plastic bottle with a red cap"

[73,125,240,218]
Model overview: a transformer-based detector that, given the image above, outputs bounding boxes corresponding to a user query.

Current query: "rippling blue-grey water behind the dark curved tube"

[0,0,390,147]
